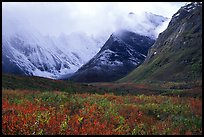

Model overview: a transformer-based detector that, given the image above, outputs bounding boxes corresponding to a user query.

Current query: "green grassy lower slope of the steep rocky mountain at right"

[118,42,202,83]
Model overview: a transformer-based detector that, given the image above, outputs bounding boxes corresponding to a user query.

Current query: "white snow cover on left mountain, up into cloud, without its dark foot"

[2,13,105,79]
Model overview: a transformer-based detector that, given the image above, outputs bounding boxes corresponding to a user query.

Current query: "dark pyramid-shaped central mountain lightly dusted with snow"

[70,30,154,82]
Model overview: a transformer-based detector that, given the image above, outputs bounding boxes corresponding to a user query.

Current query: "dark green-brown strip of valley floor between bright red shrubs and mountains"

[2,74,202,98]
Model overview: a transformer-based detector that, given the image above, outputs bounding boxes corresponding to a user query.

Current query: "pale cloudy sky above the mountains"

[2,2,186,36]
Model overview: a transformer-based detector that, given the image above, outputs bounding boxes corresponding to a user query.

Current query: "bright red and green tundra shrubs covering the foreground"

[2,90,202,135]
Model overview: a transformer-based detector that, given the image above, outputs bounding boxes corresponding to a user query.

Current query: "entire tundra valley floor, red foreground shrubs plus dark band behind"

[2,74,202,135]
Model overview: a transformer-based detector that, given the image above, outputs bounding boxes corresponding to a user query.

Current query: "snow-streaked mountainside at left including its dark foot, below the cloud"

[2,32,103,79]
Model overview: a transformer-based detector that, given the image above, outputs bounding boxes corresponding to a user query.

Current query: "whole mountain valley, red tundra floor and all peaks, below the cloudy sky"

[2,2,202,135]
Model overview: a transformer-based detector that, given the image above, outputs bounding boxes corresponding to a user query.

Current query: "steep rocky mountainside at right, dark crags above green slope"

[119,2,202,82]
